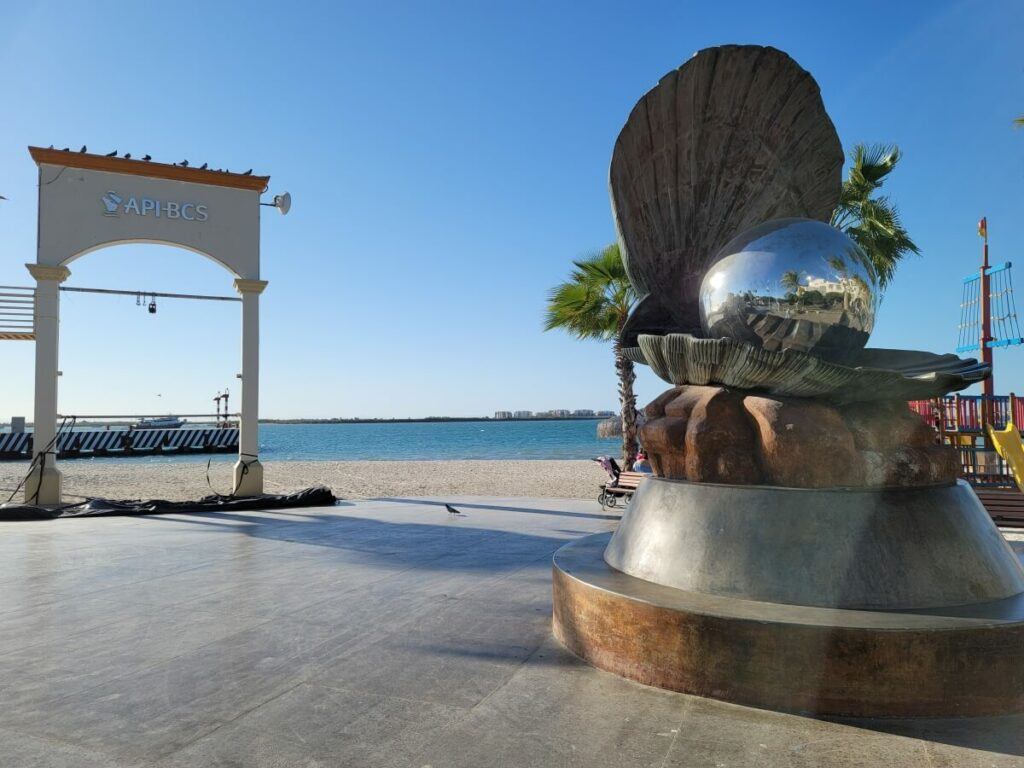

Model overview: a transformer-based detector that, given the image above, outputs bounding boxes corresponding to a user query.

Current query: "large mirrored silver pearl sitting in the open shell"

[700,218,880,362]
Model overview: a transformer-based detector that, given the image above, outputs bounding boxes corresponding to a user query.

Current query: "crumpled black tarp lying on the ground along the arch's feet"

[0,485,338,521]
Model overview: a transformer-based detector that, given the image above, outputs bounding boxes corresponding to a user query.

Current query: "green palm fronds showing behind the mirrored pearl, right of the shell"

[831,144,921,288]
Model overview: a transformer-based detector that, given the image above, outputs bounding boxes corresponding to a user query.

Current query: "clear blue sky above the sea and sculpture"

[0,0,1024,420]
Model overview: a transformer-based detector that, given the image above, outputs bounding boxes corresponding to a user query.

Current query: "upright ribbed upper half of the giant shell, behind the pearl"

[609,45,843,334]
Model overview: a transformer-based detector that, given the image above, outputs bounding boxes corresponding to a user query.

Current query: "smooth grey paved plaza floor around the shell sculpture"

[0,498,1024,768]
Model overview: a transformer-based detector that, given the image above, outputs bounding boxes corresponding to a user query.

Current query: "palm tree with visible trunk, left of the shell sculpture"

[544,245,637,465]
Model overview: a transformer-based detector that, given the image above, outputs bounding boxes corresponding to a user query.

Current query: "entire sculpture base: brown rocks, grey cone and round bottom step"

[554,385,1024,717]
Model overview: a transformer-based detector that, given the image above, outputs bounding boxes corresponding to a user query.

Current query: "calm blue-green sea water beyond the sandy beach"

[39,419,620,463]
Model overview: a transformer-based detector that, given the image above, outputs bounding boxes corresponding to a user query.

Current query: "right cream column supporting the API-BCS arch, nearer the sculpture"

[233,278,266,496]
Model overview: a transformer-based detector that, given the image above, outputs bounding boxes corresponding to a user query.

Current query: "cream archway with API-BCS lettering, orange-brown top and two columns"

[26,146,270,505]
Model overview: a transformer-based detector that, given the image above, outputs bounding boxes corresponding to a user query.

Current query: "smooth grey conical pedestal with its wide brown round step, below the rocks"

[553,478,1024,717]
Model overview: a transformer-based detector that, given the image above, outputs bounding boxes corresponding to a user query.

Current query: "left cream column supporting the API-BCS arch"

[25,264,71,505]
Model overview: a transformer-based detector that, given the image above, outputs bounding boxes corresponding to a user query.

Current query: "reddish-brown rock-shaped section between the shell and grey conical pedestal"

[640,385,958,488]
